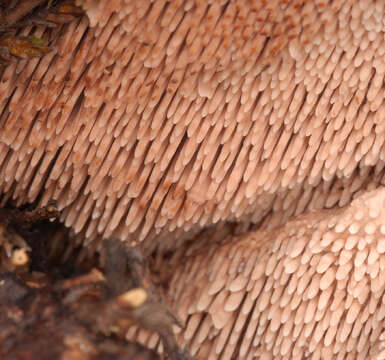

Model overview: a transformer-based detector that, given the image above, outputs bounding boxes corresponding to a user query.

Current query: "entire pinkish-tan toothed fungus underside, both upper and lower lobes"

[0,0,385,359]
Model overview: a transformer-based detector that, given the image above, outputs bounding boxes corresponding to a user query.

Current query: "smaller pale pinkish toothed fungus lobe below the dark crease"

[133,189,385,360]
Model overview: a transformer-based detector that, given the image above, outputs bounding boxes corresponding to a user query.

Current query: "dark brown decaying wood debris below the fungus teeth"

[0,203,192,360]
